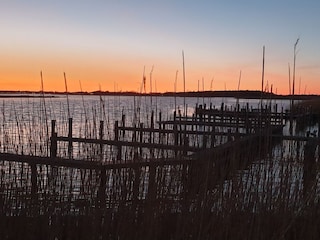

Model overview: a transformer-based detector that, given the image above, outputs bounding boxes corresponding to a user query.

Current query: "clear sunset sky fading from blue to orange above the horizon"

[0,0,320,94]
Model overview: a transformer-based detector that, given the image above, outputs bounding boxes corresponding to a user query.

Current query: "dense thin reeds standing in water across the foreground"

[0,94,320,239]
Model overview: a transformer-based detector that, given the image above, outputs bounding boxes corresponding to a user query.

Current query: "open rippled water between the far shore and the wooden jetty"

[0,95,289,158]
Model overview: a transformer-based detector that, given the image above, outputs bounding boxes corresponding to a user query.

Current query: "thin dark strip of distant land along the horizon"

[0,90,320,100]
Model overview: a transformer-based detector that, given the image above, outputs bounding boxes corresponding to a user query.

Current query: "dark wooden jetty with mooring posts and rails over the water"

[0,105,283,212]
